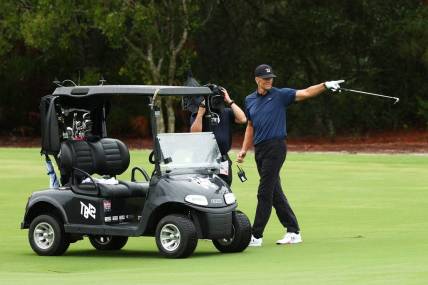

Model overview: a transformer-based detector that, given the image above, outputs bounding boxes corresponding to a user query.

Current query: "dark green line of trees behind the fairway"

[0,0,428,137]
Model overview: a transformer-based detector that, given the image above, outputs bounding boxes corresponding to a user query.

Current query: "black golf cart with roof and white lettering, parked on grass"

[21,85,251,258]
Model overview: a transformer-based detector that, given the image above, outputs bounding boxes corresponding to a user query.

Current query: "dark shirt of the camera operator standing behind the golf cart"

[190,108,235,155]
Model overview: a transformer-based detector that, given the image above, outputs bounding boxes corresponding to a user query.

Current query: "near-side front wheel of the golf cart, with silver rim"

[156,215,198,258]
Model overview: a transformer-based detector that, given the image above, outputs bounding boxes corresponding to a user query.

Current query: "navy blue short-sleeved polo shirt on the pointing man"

[245,87,296,145]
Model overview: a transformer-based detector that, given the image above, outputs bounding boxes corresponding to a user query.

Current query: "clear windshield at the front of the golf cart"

[157,133,221,172]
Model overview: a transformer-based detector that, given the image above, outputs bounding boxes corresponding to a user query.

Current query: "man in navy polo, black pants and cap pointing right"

[238,64,344,246]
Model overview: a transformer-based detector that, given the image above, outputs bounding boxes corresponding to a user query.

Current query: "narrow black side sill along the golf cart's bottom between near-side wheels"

[64,223,140,236]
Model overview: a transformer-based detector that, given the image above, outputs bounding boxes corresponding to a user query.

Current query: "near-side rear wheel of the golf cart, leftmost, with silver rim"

[28,214,70,255]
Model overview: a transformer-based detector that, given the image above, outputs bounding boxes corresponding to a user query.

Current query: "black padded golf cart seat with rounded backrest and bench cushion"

[60,138,149,198]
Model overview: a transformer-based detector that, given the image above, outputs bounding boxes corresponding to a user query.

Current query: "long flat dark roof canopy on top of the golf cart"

[53,85,212,97]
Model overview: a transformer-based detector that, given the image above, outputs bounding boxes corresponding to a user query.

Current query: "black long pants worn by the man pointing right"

[253,140,300,238]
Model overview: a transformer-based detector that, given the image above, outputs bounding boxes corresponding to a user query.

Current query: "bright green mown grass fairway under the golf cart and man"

[0,148,428,285]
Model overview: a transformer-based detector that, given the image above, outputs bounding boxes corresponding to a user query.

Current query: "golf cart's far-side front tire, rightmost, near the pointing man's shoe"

[213,212,251,253]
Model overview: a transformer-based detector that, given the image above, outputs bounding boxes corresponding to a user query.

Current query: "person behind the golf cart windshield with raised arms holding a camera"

[190,88,247,186]
